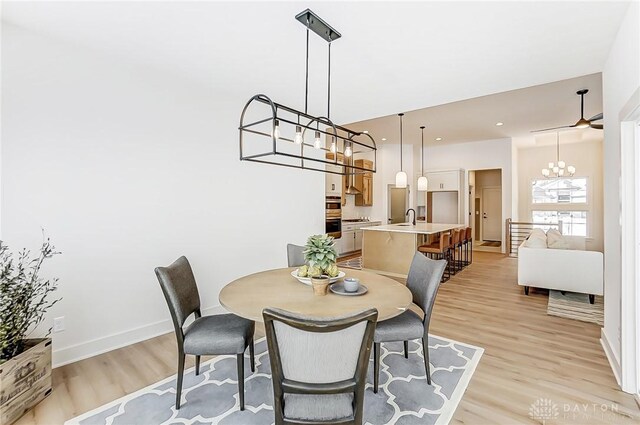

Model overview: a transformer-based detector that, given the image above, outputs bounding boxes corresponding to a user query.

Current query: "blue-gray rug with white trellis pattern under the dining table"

[65,336,484,425]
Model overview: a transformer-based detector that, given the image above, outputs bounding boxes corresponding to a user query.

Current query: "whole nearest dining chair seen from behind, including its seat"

[262,308,378,425]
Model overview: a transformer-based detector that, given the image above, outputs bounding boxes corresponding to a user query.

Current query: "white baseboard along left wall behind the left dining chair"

[52,305,227,368]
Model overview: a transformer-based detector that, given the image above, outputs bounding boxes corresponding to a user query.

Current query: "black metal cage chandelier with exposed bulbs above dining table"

[239,9,377,176]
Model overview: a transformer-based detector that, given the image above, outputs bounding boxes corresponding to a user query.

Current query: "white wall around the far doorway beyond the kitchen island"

[424,139,512,252]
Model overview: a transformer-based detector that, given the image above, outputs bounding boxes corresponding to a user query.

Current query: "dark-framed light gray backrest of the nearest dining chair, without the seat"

[262,308,378,423]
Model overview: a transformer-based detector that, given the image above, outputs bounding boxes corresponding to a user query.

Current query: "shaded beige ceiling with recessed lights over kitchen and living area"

[347,73,603,146]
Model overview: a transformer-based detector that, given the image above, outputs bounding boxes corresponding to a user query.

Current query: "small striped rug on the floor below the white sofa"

[547,290,604,326]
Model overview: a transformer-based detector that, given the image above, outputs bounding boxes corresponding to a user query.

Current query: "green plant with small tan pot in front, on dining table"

[298,235,340,295]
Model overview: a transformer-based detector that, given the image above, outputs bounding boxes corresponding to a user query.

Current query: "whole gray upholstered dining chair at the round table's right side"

[373,252,447,393]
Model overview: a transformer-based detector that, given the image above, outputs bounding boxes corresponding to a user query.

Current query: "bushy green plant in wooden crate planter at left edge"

[0,239,59,424]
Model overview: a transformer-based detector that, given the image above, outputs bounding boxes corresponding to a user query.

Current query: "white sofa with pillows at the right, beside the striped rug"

[518,230,603,304]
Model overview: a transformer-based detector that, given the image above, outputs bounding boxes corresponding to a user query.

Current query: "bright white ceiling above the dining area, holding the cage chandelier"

[2,1,629,129]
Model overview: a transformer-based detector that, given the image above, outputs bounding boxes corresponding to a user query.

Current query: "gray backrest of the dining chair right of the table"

[407,252,447,329]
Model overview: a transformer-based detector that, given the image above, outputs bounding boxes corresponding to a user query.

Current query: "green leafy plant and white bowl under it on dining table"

[291,235,345,285]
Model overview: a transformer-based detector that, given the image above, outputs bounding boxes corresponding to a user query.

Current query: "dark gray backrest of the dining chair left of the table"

[155,256,200,332]
